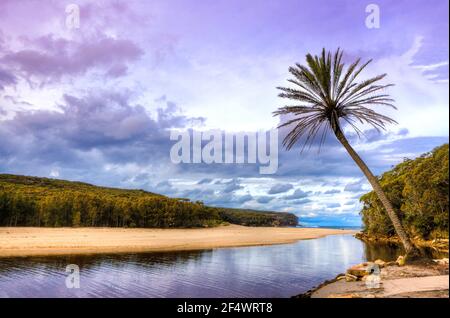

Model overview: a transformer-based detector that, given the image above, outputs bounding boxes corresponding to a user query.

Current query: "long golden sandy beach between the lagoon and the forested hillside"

[0,225,355,257]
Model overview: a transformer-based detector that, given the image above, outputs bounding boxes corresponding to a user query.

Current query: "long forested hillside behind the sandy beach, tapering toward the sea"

[0,174,296,228]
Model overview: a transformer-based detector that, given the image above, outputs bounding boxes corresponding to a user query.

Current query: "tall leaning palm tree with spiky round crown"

[274,49,417,256]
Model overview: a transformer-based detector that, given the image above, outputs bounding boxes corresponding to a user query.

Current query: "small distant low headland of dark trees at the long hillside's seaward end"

[219,208,298,226]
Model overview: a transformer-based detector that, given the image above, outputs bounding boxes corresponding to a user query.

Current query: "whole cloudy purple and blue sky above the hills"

[0,0,449,225]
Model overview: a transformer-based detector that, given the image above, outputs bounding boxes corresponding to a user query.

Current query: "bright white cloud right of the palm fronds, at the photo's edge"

[371,36,449,136]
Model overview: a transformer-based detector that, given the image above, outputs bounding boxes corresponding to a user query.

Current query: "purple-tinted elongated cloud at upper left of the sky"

[0,34,143,82]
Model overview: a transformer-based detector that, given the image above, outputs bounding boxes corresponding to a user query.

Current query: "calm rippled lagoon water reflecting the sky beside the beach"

[0,235,442,297]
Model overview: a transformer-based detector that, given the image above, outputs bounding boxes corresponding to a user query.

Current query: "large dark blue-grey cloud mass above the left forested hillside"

[0,92,199,175]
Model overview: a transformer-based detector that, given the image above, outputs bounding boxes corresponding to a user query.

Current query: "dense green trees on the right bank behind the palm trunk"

[360,144,449,239]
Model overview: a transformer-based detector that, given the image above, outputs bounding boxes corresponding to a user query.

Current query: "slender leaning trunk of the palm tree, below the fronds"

[335,128,418,257]
